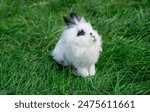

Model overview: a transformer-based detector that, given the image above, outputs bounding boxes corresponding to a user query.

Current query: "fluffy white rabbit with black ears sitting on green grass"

[51,12,102,77]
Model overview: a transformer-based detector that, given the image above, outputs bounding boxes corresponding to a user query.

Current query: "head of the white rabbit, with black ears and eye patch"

[63,12,101,46]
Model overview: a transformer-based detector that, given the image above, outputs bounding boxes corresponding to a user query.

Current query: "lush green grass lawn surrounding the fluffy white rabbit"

[0,0,150,95]
